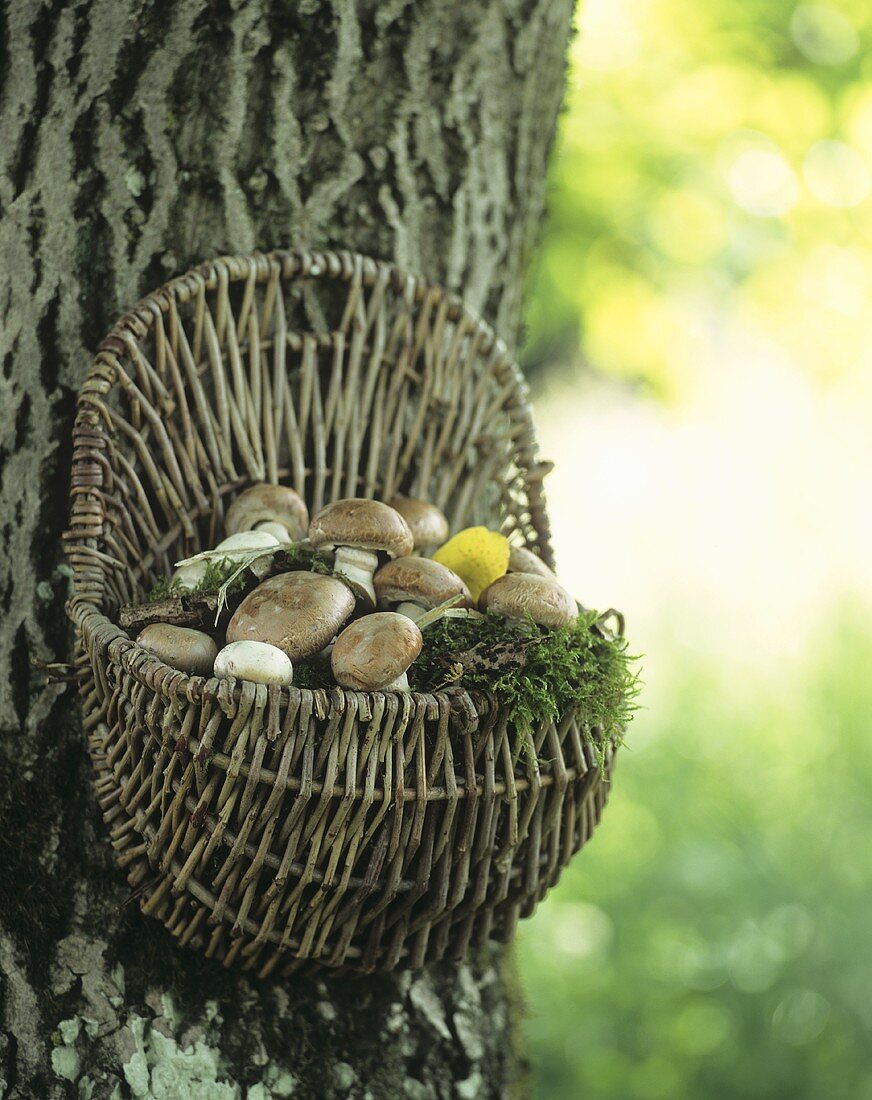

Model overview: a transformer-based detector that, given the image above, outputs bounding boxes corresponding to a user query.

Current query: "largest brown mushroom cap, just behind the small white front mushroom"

[227,571,354,660]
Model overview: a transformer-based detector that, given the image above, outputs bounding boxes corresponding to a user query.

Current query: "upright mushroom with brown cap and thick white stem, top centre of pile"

[309,497,413,607]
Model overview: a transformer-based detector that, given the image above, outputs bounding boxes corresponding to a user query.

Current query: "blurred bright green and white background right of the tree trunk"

[519,0,872,1100]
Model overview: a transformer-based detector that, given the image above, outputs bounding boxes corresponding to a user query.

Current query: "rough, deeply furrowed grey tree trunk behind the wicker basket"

[0,0,571,1100]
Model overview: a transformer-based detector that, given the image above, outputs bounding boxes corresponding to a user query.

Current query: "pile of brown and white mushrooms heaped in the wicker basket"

[129,484,578,691]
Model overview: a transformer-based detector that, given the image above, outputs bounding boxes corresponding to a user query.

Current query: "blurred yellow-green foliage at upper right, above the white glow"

[527,0,872,395]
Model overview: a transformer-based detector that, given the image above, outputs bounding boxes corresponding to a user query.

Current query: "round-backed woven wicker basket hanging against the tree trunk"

[66,252,607,975]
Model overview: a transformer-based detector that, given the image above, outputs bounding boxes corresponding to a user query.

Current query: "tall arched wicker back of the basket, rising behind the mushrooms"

[71,252,551,616]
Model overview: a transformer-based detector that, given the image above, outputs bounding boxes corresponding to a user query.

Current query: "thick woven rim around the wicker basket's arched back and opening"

[68,248,554,704]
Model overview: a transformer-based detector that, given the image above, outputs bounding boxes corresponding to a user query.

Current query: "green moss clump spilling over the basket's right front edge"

[409,612,638,766]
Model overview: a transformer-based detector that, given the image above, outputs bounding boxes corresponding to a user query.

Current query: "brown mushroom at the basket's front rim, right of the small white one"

[330,612,423,691]
